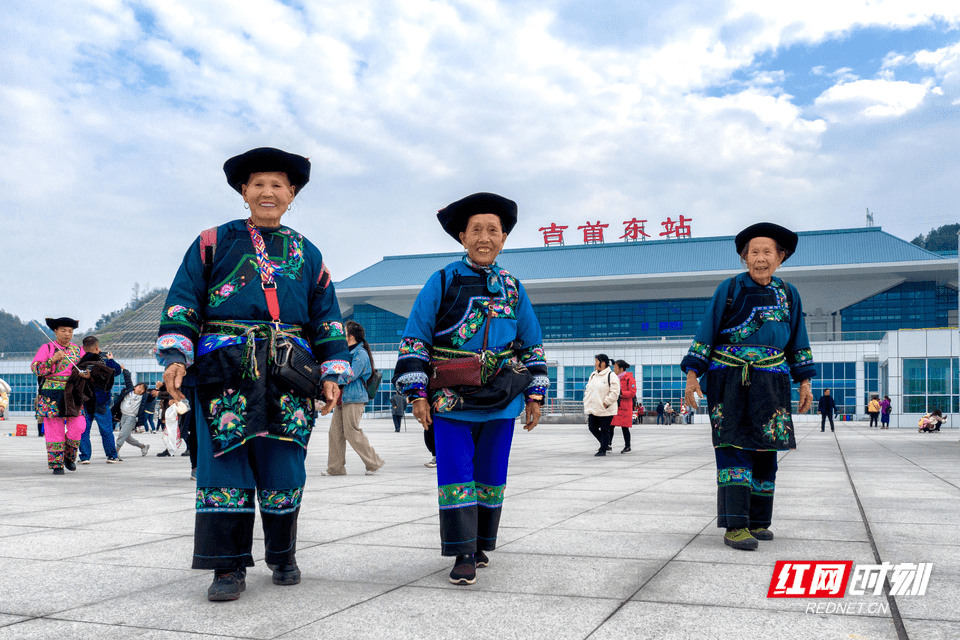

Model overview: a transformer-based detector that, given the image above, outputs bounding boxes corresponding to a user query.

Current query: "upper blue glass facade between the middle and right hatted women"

[533,298,710,341]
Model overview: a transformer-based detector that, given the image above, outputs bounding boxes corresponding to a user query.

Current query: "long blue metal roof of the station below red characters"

[336,227,943,289]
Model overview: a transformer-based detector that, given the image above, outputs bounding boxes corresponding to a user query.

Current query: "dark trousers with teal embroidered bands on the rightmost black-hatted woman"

[714,447,778,529]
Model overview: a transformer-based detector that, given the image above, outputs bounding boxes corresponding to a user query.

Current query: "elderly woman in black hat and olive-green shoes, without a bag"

[680,222,816,550]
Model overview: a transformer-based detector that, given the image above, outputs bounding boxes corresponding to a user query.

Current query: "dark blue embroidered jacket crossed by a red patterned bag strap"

[157,220,350,382]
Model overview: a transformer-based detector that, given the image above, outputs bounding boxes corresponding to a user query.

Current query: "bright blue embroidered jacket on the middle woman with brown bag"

[394,258,550,422]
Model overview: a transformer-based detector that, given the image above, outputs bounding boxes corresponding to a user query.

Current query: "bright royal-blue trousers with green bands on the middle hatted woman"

[432,414,515,556]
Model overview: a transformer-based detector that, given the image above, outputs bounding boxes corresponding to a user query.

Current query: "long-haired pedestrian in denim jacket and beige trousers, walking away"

[322,320,383,476]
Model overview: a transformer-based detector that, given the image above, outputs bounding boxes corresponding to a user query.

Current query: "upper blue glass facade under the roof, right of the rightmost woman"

[840,281,957,334]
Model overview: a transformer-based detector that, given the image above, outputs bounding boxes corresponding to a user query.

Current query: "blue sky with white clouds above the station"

[0,0,960,327]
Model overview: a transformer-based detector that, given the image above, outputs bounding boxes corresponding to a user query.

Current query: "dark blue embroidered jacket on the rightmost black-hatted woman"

[680,272,816,382]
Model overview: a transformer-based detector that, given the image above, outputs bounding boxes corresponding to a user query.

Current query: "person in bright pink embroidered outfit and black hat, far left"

[30,318,89,475]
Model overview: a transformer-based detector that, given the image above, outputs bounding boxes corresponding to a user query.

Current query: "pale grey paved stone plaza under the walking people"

[0,418,960,640]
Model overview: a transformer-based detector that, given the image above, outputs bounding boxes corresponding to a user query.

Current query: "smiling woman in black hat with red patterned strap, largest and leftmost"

[157,148,350,600]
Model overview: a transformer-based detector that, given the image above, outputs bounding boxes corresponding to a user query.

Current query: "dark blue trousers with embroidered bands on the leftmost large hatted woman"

[191,395,307,569]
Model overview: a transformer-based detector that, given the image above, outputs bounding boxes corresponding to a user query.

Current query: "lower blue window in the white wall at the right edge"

[903,358,960,414]
